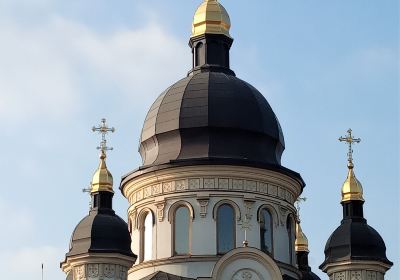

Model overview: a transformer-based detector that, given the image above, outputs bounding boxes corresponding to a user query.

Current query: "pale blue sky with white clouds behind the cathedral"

[0,0,400,280]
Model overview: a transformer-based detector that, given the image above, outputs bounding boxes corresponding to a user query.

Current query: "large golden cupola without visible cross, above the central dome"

[192,0,231,37]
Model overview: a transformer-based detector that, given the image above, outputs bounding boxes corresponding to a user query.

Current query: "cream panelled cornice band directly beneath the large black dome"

[123,166,301,209]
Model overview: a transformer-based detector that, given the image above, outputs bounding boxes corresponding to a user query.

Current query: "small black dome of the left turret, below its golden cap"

[66,209,135,257]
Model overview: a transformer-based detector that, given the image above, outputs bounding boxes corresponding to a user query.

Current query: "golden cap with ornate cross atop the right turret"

[339,129,364,202]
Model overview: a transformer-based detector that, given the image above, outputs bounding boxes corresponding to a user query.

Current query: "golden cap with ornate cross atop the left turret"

[91,119,115,193]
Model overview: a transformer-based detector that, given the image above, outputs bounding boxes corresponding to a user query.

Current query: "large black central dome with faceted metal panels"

[140,71,284,166]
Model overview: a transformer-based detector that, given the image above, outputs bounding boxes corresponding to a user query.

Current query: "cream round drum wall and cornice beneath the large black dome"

[123,165,301,280]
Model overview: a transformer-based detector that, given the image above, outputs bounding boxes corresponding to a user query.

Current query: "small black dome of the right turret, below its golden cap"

[320,218,392,268]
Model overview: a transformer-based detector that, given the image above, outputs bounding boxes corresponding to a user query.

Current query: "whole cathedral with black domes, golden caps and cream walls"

[61,0,393,280]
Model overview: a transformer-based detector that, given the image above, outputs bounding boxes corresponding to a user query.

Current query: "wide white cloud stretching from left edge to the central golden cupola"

[0,12,190,123]
